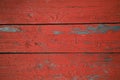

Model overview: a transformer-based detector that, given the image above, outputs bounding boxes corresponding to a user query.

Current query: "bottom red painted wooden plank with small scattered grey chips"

[0,53,120,80]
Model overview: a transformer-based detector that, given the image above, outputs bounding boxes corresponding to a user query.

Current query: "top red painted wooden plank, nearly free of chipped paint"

[0,0,120,24]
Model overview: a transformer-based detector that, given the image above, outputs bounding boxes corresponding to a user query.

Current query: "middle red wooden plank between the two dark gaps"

[0,24,120,52]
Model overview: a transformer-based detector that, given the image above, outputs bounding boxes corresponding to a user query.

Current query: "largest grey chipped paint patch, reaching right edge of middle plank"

[72,24,120,34]
